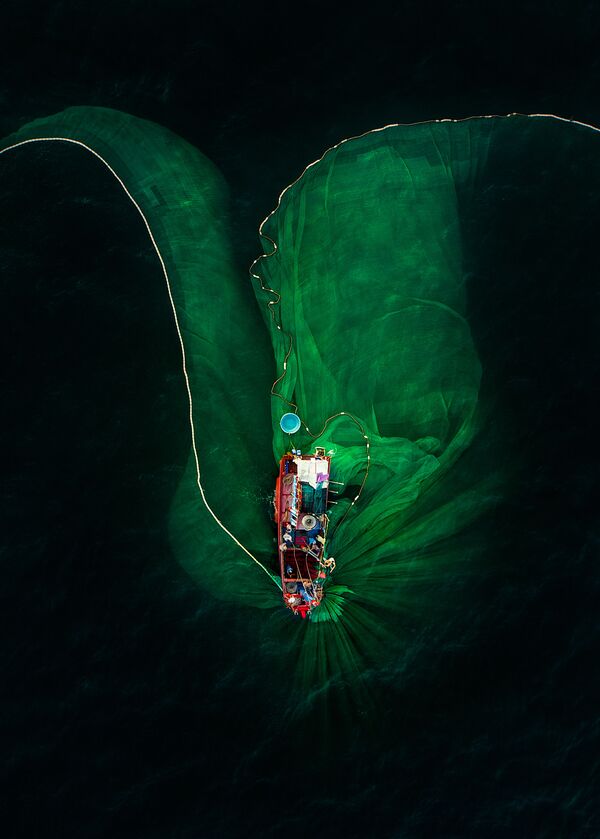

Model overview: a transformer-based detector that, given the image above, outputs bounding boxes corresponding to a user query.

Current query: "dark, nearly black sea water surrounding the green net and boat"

[0,2,600,839]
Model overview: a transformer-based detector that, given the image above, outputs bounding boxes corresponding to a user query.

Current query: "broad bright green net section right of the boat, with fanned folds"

[254,122,500,680]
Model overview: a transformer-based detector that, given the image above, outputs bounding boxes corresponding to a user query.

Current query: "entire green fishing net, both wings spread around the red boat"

[3,108,590,692]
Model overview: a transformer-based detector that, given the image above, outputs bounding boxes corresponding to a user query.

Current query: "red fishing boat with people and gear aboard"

[274,448,335,618]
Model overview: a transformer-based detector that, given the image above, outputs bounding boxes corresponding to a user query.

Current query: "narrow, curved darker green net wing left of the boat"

[2,108,279,607]
